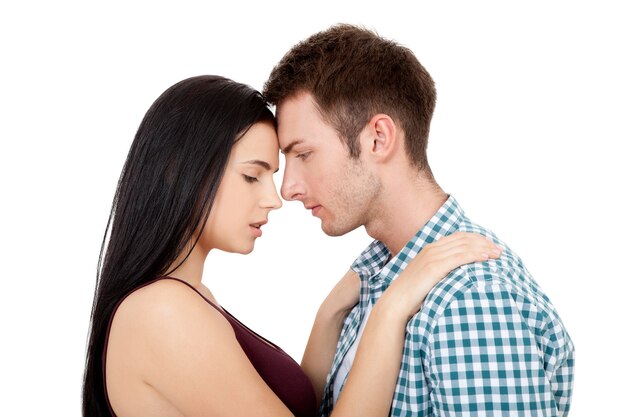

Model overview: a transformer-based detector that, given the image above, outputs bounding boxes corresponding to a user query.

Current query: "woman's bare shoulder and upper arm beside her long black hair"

[106,280,291,417]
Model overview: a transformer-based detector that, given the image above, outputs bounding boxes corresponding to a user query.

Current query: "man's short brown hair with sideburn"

[263,24,437,174]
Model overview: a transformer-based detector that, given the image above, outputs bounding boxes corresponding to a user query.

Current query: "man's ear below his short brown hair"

[361,113,400,161]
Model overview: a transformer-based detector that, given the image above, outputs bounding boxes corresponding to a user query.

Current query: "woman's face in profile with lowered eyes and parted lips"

[198,122,282,253]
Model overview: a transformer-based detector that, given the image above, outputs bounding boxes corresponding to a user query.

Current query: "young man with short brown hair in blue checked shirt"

[264,25,574,416]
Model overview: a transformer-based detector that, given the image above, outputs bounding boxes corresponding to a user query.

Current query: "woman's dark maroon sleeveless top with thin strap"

[102,277,317,417]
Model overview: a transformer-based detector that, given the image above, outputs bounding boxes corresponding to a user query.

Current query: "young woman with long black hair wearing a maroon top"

[83,76,499,417]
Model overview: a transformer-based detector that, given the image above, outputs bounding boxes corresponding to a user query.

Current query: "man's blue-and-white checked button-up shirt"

[320,197,574,416]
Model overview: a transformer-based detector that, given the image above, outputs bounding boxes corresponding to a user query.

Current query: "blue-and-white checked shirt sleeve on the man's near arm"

[427,281,569,417]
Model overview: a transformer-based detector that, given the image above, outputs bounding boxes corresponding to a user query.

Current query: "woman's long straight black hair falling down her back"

[83,75,274,417]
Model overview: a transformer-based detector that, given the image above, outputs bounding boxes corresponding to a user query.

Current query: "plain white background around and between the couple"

[0,1,626,417]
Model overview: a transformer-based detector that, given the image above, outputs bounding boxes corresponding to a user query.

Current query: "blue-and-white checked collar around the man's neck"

[352,195,465,288]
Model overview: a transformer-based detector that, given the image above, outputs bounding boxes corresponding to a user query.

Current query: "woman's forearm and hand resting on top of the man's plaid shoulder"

[332,233,501,417]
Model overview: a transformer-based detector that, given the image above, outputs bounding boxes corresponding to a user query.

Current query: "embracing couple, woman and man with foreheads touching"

[83,25,574,417]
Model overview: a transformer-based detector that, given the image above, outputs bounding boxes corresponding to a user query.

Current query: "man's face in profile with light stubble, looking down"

[277,93,380,236]
